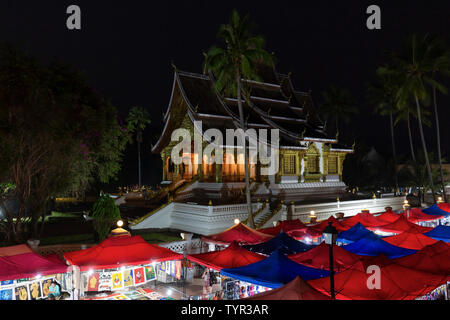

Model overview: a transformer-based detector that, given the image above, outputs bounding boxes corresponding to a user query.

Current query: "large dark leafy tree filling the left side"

[0,47,128,242]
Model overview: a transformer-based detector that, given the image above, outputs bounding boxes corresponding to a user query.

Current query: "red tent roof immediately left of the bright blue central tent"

[187,242,267,271]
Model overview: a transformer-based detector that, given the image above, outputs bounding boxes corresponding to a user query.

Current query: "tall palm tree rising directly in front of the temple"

[204,10,273,228]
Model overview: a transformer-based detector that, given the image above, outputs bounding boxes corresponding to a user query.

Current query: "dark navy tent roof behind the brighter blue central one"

[243,231,315,255]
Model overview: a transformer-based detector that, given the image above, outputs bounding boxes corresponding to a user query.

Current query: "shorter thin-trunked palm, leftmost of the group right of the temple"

[368,70,398,193]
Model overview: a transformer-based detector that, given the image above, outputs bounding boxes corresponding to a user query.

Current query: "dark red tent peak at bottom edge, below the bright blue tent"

[243,276,330,300]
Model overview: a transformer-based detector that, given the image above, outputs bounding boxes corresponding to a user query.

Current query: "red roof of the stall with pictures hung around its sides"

[64,235,183,271]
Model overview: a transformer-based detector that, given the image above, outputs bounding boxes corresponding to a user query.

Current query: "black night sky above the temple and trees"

[0,0,450,188]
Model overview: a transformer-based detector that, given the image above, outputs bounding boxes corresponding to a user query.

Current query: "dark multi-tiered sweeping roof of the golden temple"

[152,66,352,153]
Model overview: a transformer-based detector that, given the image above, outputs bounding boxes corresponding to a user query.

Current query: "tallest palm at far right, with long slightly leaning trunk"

[388,34,446,202]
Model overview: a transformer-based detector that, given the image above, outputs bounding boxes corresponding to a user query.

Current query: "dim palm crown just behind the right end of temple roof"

[320,86,358,134]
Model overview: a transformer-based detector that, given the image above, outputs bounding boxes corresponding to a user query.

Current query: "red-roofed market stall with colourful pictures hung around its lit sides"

[64,234,183,297]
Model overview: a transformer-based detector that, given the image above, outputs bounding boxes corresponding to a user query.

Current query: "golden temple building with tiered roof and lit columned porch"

[152,66,353,199]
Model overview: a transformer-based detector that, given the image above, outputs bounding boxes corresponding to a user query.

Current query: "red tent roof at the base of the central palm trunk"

[202,223,273,244]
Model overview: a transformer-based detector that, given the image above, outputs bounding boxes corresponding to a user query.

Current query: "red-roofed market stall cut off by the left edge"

[0,244,72,300]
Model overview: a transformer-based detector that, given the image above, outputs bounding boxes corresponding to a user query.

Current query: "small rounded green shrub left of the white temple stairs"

[92,192,120,241]
